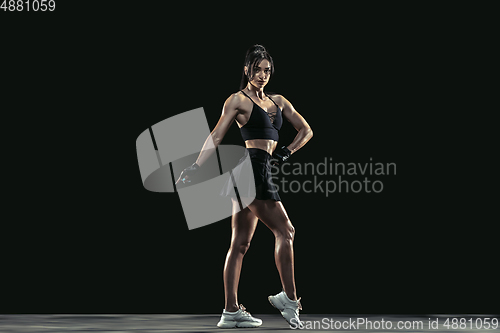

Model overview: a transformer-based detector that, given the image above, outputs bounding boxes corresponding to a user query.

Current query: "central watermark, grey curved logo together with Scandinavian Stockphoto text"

[136,108,396,230]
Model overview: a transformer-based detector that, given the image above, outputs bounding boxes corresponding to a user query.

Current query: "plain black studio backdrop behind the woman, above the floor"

[0,1,498,313]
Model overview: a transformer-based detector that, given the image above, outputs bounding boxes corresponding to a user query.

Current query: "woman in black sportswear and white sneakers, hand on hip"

[177,45,313,328]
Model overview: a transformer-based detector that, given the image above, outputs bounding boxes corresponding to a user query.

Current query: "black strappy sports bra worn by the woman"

[240,90,283,141]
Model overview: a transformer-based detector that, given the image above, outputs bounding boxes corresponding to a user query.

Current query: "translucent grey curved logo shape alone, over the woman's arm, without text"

[136,108,255,230]
